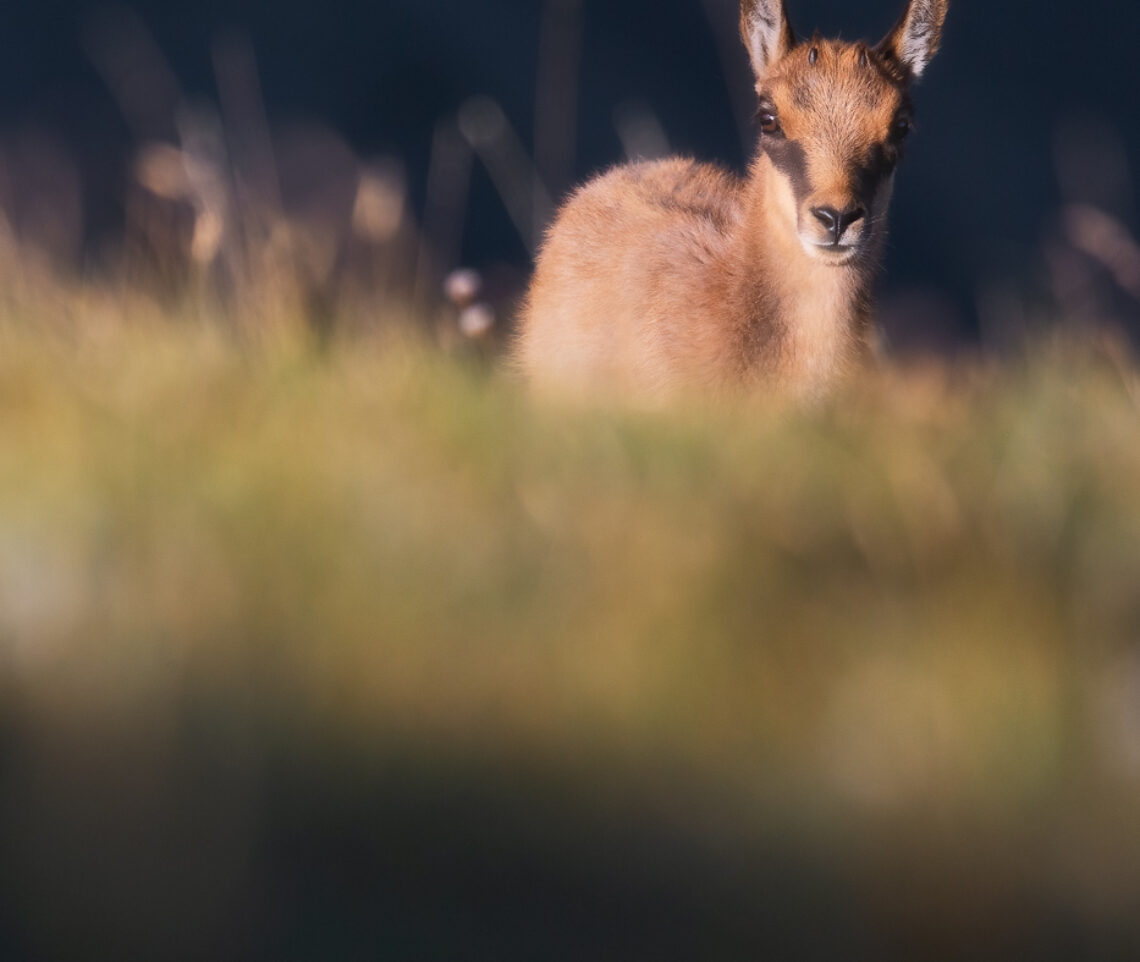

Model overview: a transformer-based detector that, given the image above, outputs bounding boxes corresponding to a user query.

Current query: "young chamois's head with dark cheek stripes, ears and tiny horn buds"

[740,0,948,264]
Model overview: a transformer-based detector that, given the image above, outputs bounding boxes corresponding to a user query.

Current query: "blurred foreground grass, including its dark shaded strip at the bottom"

[0,281,1140,960]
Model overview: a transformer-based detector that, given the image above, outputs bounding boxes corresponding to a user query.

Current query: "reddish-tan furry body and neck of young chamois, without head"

[519,160,870,397]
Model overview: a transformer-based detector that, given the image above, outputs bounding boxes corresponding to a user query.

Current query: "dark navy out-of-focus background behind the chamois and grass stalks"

[0,0,1140,340]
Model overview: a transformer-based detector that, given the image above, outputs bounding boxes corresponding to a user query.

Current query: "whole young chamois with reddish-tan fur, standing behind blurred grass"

[515,0,948,399]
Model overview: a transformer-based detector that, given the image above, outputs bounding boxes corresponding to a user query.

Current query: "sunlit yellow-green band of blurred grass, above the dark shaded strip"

[0,281,1140,952]
